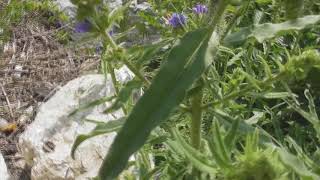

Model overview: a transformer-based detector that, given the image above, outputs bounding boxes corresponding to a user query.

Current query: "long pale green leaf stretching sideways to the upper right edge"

[223,15,320,46]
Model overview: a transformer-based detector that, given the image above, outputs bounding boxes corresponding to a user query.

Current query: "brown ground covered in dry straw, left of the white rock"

[0,10,99,180]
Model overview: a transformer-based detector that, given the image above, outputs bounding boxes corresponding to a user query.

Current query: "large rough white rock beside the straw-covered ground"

[19,67,133,180]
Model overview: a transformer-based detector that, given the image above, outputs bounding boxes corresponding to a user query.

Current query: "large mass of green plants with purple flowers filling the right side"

[2,0,320,180]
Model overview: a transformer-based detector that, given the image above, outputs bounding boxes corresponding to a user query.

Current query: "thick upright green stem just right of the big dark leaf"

[191,89,203,149]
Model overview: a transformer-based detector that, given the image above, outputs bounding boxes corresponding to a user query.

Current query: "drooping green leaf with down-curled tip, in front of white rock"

[71,118,126,159]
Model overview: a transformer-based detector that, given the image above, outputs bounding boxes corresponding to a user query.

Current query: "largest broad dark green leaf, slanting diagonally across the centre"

[99,29,218,179]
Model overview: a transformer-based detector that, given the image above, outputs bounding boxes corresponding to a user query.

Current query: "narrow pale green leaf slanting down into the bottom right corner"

[278,148,320,180]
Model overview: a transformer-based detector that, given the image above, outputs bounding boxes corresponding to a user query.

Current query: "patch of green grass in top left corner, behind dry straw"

[0,0,69,51]
